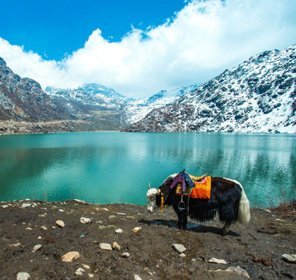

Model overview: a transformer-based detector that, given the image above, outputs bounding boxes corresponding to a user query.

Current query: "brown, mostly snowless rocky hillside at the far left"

[0,58,74,121]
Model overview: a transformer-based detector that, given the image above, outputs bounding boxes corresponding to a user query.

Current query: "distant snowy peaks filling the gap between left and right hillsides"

[45,83,197,126]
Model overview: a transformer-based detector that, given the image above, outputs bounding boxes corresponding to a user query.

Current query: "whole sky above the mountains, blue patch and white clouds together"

[0,0,296,97]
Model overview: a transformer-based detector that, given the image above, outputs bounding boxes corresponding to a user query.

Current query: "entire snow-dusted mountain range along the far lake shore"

[0,46,296,133]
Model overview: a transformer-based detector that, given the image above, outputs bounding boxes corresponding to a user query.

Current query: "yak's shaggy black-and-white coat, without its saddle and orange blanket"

[147,174,251,234]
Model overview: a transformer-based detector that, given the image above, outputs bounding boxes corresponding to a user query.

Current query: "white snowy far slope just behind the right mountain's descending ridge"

[125,85,198,124]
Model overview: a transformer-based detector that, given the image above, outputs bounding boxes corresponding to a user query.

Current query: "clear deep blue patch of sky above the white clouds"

[0,0,184,60]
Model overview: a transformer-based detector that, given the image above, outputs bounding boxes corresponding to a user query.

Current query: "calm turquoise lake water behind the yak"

[0,132,296,207]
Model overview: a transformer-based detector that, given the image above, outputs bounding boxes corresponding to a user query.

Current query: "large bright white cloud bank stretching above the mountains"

[0,0,296,97]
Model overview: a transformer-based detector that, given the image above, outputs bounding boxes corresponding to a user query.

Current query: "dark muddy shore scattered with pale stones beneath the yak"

[0,200,296,280]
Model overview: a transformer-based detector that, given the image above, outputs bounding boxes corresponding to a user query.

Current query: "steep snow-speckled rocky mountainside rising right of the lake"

[127,45,296,133]
